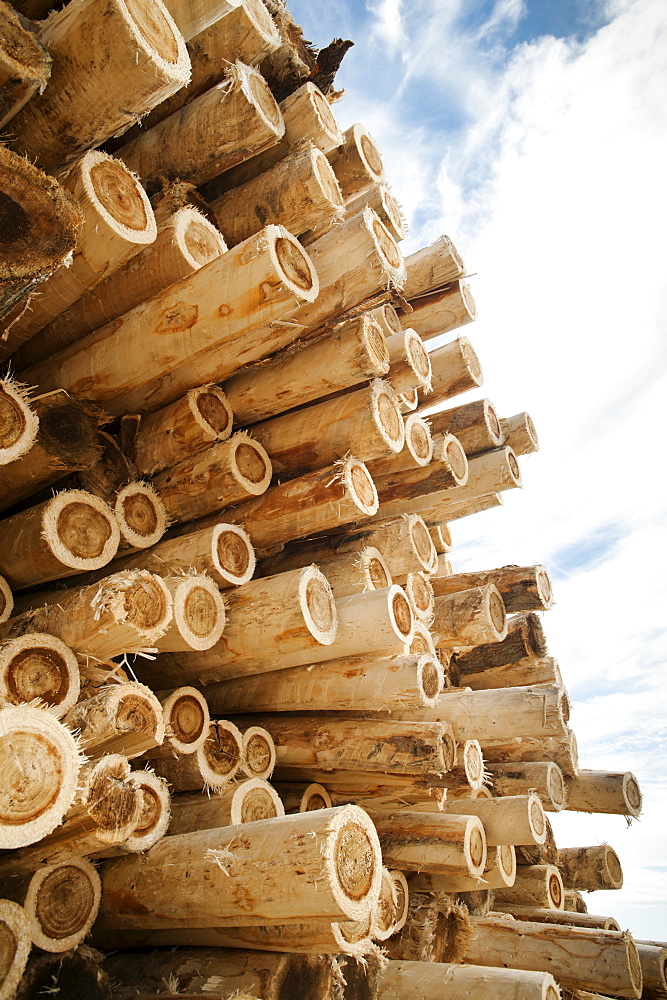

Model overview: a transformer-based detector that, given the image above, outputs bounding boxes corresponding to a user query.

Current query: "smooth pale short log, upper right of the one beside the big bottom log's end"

[440,792,547,847]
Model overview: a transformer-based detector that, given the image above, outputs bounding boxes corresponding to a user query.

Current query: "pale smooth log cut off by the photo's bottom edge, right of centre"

[379,960,560,1000]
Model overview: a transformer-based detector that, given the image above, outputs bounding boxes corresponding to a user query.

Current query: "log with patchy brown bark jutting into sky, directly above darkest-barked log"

[433,564,553,615]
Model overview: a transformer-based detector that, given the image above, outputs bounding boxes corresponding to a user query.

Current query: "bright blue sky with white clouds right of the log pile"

[289,0,667,940]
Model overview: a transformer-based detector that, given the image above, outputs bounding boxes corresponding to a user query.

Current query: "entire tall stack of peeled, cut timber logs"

[0,0,656,1000]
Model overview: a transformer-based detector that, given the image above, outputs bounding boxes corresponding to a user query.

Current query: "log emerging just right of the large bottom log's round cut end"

[368,807,486,877]
